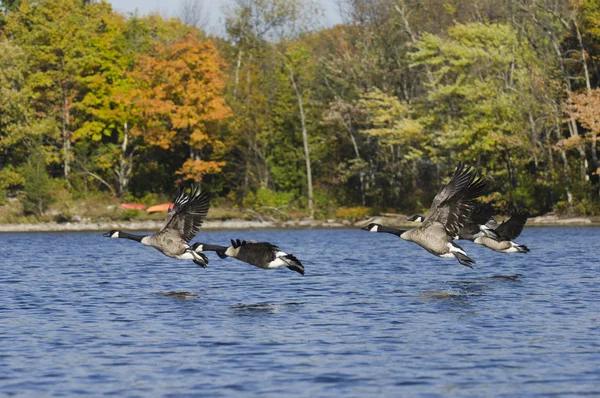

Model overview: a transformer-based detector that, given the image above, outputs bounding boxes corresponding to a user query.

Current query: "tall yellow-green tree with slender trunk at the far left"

[6,0,115,179]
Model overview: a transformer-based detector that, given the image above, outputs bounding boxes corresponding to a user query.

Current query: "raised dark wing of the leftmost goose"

[159,184,210,243]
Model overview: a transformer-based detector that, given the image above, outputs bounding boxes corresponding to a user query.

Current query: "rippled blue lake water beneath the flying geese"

[0,228,600,397]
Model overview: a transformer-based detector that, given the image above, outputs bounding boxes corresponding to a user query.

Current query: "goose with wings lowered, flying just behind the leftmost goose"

[192,239,304,275]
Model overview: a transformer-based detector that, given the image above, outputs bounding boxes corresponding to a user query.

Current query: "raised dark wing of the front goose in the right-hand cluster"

[421,164,485,239]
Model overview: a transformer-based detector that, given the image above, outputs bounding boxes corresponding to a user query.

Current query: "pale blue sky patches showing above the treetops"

[108,0,341,34]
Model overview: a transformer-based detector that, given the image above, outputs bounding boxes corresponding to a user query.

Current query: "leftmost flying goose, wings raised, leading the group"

[104,184,210,267]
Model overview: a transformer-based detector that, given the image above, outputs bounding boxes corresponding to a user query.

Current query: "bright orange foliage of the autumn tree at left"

[133,35,231,148]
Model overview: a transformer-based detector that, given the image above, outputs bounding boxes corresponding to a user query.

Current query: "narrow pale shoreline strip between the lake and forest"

[0,215,600,233]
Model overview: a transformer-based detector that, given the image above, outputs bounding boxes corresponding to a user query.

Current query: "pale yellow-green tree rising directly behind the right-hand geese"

[412,24,552,210]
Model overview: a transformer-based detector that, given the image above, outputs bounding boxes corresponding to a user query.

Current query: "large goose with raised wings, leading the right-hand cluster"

[362,164,485,268]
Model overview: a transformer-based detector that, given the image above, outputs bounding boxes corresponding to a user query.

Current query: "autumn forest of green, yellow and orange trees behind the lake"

[0,0,600,222]
